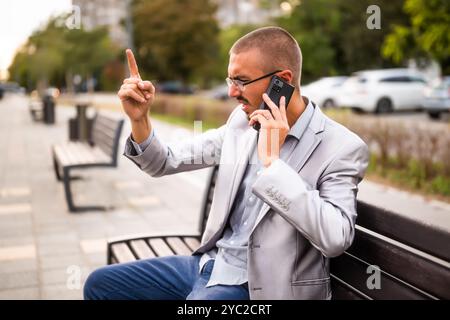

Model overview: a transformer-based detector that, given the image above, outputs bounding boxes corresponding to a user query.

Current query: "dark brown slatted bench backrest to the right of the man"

[330,202,450,299]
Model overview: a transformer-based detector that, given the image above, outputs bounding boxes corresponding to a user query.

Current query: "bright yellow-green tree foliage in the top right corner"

[383,0,450,73]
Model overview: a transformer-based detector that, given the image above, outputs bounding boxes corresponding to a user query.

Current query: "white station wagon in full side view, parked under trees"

[337,69,426,113]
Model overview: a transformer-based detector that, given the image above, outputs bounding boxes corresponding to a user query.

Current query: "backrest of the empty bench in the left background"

[91,112,123,165]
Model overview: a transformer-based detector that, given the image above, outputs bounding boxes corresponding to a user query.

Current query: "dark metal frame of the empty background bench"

[52,113,124,212]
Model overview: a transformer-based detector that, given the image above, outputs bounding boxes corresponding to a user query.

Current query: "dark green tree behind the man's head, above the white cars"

[277,0,406,83]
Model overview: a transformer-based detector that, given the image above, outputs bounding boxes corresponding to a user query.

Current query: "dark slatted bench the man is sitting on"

[107,167,450,300]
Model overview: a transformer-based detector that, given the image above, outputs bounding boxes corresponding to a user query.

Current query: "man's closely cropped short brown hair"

[230,27,302,88]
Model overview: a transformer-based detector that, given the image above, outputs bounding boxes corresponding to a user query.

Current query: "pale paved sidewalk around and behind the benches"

[0,96,450,299]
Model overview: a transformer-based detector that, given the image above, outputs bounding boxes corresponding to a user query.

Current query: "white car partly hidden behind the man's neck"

[301,76,348,108]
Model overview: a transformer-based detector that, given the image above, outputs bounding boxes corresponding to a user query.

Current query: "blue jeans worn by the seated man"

[84,255,249,300]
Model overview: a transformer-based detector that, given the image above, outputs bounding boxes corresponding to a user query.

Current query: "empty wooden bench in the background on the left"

[52,113,123,212]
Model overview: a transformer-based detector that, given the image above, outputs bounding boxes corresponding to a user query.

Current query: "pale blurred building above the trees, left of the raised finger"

[72,0,128,47]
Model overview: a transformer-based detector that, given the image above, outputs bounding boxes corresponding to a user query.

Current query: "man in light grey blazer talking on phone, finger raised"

[85,27,368,299]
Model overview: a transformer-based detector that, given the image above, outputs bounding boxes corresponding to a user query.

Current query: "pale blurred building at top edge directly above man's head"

[214,0,281,27]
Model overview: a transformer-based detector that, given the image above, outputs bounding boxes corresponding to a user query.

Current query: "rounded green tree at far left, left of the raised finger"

[9,15,119,90]
